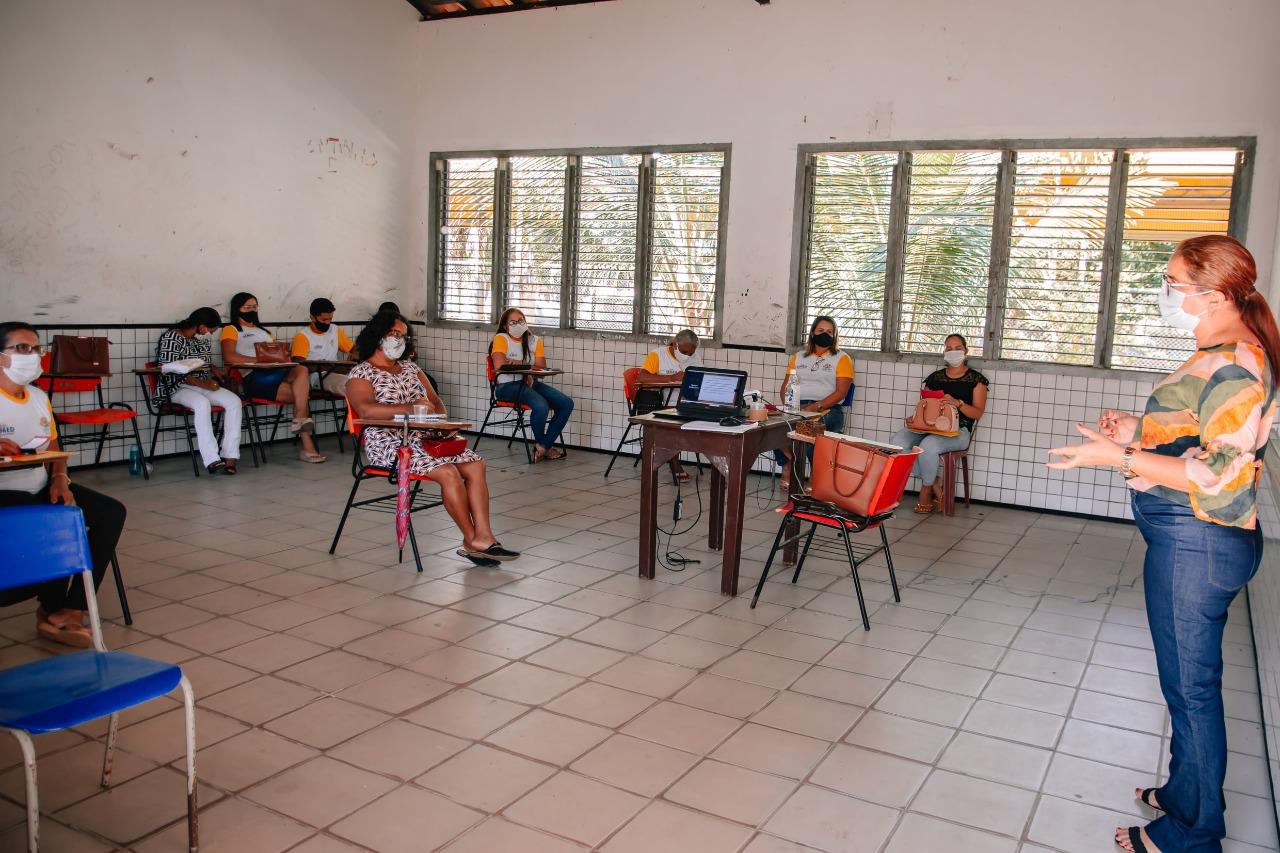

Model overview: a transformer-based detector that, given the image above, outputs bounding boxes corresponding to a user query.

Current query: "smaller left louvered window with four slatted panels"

[431,146,727,337]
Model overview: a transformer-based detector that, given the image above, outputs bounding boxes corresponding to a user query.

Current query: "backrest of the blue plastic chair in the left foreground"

[0,505,93,589]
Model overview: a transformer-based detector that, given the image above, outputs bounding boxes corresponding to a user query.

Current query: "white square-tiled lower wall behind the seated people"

[41,323,1152,517]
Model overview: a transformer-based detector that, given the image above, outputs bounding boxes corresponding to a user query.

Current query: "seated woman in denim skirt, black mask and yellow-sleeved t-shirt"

[219,293,325,462]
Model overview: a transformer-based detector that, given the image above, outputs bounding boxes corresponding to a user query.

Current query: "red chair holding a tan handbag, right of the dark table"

[751,447,920,630]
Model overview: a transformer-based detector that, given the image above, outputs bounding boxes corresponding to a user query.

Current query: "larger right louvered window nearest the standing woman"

[795,137,1254,370]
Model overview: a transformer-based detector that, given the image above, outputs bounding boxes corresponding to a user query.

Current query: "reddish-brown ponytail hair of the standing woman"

[1174,234,1280,387]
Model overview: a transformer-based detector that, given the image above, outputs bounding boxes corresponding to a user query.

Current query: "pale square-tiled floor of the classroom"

[0,439,1277,853]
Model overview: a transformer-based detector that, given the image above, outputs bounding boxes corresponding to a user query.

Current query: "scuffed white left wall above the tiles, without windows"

[0,0,417,323]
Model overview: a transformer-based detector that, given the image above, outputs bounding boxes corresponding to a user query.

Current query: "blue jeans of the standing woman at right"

[1133,492,1262,853]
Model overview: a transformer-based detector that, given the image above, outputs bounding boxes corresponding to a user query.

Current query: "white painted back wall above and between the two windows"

[412,0,1280,345]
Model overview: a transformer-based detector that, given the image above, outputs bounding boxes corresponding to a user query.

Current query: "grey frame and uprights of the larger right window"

[787,136,1257,378]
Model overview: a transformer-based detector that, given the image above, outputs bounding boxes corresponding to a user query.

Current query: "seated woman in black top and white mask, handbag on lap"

[890,334,991,515]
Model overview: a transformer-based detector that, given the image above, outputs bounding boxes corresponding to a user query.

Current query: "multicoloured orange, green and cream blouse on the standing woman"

[1129,341,1276,530]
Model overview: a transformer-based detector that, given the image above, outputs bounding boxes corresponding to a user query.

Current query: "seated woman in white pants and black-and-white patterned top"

[155,307,243,474]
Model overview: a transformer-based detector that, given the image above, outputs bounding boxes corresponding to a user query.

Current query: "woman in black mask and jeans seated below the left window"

[489,307,573,462]
